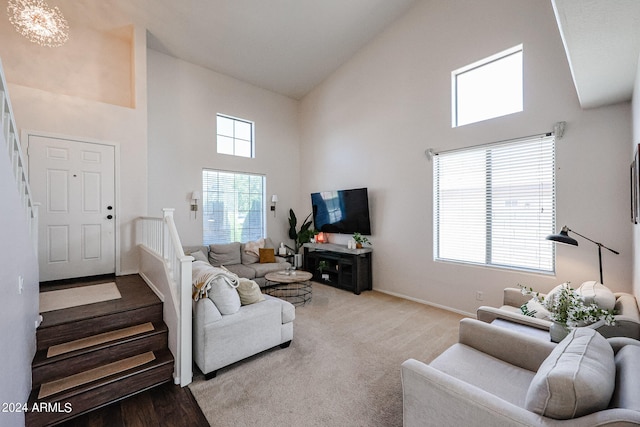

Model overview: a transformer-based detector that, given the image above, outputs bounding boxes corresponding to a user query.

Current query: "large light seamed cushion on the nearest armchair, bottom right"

[525,328,616,419]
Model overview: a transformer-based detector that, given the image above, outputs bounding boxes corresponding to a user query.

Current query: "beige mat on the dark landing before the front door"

[40,282,121,313]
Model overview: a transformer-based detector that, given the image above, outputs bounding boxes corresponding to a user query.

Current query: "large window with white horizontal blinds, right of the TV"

[433,135,555,272]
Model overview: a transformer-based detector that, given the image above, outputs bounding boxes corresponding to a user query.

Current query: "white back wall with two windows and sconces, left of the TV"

[147,50,306,249]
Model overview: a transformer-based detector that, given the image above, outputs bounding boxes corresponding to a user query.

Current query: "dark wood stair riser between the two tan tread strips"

[32,322,168,388]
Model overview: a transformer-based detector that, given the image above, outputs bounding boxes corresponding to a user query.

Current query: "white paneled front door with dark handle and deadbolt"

[28,135,115,282]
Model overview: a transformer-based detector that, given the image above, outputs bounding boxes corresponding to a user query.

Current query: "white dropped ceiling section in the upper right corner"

[553,0,640,108]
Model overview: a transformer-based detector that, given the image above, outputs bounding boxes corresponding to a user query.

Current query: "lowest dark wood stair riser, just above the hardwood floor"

[25,349,174,427]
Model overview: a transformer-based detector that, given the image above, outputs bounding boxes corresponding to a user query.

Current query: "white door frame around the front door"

[20,129,121,276]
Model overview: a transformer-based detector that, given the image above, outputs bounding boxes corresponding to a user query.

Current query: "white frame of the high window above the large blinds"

[451,44,524,128]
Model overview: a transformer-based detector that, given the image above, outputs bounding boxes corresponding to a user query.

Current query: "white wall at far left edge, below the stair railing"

[0,134,38,426]
